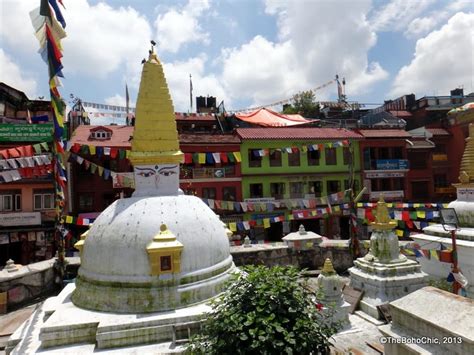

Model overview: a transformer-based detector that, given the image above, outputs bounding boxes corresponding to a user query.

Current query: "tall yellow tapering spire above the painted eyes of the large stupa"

[130,46,183,166]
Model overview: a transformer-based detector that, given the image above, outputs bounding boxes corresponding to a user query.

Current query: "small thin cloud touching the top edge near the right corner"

[370,0,434,31]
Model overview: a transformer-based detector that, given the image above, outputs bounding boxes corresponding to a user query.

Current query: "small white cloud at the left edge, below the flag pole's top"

[0,48,37,99]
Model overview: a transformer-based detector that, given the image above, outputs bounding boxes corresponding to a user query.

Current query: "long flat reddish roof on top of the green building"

[236,127,363,140]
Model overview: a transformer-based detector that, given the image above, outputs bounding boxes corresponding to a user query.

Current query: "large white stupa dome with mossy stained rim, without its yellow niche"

[73,195,234,312]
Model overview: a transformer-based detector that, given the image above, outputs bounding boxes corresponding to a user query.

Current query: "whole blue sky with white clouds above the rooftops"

[0,0,474,122]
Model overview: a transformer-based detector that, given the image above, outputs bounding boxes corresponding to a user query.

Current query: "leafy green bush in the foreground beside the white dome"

[187,266,338,355]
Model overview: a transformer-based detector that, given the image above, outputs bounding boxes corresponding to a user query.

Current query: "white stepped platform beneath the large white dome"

[7,284,211,354]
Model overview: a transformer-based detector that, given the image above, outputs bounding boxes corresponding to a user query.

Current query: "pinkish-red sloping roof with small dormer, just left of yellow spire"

[71,125,134,148]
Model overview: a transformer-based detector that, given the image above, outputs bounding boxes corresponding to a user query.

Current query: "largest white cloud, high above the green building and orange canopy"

[220,0,388,109]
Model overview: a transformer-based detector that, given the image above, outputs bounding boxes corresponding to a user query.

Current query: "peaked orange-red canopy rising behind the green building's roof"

[235,108,314,127]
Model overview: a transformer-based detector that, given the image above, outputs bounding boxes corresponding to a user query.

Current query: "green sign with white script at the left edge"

[0,123,53,142]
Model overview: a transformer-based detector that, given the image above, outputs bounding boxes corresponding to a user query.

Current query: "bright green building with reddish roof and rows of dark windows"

[237,127,363,240]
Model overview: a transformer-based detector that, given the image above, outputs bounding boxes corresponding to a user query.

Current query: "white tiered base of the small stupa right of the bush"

[349,258,428,319]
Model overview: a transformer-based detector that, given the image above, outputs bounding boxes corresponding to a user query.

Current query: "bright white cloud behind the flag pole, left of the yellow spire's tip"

[0,0,152,85]
